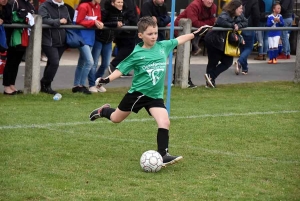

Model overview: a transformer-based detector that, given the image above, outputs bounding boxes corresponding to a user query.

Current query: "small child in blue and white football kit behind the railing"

[267,3,284,64]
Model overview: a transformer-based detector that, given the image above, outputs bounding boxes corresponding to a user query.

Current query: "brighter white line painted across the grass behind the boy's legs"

[0,110,300,130]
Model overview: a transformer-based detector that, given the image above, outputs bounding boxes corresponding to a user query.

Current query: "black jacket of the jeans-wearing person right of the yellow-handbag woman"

[242,0,260,27]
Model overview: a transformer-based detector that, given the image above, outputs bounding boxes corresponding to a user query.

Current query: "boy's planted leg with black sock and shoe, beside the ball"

[149,107,183,167]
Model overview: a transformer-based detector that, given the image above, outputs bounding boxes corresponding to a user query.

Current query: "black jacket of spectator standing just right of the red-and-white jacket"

[96,0,125,43]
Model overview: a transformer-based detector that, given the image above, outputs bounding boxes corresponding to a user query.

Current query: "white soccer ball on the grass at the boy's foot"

[140,150,163,172]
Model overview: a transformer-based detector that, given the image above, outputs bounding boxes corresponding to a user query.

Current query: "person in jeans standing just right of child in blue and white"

[277,0,295,59]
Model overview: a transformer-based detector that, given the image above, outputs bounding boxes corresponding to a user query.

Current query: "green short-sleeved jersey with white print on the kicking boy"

[117,39,178,99]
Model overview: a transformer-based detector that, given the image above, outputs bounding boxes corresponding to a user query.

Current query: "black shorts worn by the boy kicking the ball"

[118,92,166,116]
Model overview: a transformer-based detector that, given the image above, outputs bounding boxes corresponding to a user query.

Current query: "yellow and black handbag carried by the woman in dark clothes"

[224,31,244,57]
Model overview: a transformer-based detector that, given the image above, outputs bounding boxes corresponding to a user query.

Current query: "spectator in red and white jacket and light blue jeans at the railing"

[72,0,103,94]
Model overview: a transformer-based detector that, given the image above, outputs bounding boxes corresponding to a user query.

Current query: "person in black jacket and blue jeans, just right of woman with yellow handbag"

[235,0,260,75]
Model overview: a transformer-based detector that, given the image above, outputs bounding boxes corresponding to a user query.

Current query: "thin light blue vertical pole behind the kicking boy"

[166,0,176,116]
